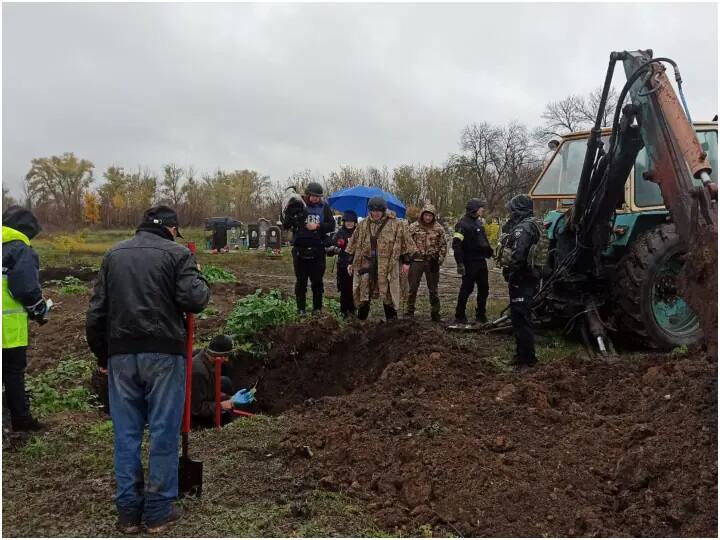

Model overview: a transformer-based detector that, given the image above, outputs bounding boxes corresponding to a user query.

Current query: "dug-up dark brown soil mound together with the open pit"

[253,320,717,536]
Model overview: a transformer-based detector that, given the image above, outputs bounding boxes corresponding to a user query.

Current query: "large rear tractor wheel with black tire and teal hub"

[614,224,704,350]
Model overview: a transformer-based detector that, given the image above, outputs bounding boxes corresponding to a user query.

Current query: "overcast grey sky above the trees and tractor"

[2,3,718,195]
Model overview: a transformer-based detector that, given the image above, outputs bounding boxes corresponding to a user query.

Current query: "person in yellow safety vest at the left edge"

[2,205,48,431]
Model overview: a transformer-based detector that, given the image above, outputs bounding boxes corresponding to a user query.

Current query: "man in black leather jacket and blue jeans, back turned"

[86,206,210,534]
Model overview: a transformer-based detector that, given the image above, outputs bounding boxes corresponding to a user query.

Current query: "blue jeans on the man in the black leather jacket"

[108,353,185,525]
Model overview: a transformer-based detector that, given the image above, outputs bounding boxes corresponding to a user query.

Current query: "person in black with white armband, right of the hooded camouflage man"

[452,199,493,324]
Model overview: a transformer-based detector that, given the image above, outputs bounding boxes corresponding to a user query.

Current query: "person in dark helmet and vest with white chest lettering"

[283,182,335,315]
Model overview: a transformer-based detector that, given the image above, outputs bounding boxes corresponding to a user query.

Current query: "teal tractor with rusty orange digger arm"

[530,50,718,354]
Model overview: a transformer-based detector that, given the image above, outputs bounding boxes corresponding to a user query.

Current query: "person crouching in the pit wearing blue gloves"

[191,334,235,427]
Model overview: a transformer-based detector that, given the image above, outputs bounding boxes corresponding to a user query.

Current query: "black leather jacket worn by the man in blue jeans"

[86,227,210,366]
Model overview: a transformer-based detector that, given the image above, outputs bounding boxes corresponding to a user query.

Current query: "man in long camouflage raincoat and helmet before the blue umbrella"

[346,197,417,320]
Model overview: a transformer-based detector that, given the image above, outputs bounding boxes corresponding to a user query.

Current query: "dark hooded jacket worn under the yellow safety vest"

[2,206,42,307]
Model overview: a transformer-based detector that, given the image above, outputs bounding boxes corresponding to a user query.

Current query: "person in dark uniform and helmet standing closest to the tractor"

[500,195,544,368]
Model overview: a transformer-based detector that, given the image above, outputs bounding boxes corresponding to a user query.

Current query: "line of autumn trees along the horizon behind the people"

[3,91,616,229]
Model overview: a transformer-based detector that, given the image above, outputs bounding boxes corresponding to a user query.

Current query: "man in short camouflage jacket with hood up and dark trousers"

[405,204,447,321]
